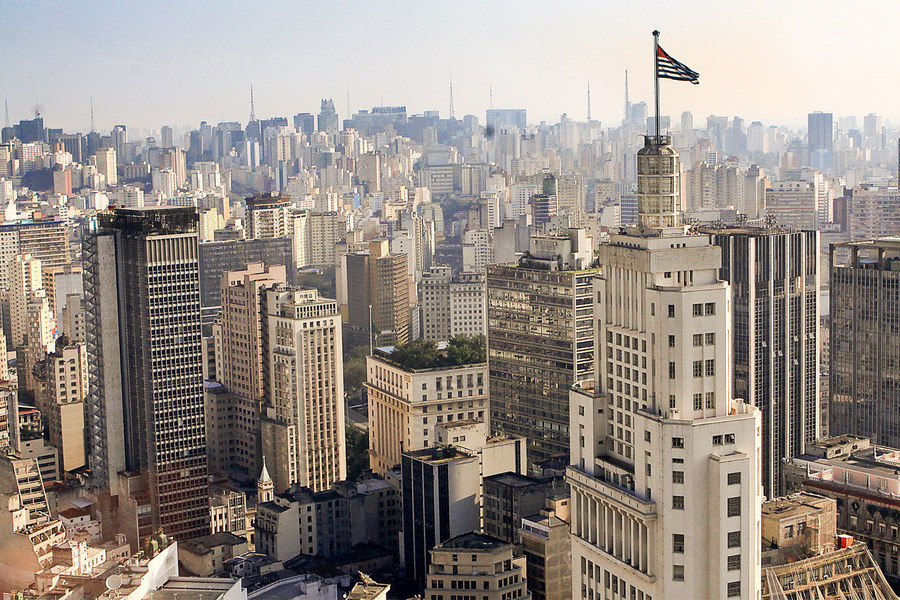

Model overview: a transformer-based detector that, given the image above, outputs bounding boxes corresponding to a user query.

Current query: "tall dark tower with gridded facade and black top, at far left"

[84,207,209,543]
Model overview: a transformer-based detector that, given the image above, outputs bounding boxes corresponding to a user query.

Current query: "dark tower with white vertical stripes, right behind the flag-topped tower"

[712,227,821,498]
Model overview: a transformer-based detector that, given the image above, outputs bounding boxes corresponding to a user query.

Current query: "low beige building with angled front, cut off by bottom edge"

[423,532,532,600]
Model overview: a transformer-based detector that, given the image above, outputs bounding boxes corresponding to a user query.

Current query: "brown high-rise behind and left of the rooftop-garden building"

[344,240,412,346]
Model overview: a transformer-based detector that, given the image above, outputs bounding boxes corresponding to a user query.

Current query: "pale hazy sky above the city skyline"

[0,0,900,131]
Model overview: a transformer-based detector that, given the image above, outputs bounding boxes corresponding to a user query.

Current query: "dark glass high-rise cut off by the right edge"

[828,238,900,448]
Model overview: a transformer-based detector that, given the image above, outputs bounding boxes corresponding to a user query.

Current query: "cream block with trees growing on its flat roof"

[365,349,490,475]
